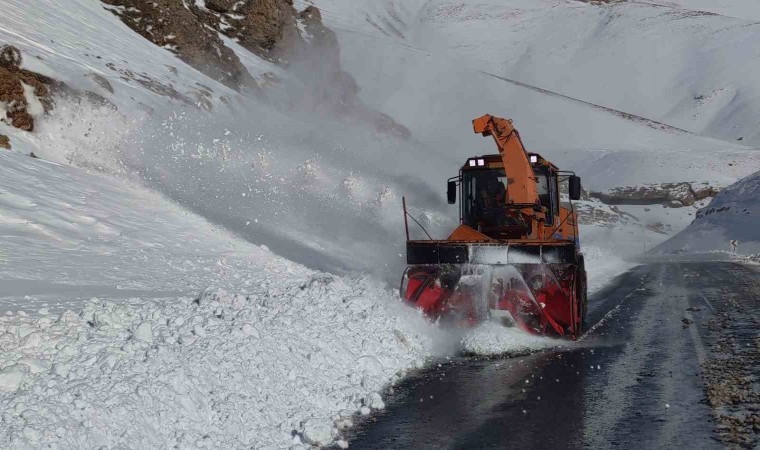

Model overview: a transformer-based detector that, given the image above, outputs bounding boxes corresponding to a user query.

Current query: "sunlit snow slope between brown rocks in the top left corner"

[0,0,234,117]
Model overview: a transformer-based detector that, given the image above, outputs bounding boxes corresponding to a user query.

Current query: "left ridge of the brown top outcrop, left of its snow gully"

[96,0,255,90]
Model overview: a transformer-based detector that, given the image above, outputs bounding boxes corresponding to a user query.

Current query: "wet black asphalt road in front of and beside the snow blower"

[350,262,760,449]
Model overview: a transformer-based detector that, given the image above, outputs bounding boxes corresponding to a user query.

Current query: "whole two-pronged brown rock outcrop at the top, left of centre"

[101,0,305,90]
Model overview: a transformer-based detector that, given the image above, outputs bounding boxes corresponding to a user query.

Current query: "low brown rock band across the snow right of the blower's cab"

[590,182,718,208]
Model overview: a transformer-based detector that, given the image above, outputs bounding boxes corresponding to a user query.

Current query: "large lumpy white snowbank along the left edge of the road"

[0,276,446,448]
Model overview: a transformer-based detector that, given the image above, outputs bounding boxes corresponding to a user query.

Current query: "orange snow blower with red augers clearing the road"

[400,115,587,339]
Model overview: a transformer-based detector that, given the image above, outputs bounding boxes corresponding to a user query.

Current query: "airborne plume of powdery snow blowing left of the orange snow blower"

[115,101,455,284]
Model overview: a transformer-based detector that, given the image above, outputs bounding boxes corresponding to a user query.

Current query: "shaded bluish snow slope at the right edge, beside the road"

[656,172,760,255]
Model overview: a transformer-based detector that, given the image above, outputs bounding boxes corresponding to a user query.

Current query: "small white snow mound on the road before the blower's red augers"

[462,322,561,356]
